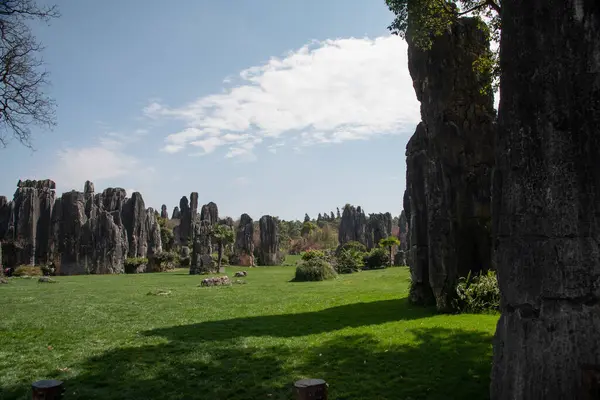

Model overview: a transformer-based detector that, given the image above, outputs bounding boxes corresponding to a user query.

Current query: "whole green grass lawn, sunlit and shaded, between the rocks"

[0,267,498,400]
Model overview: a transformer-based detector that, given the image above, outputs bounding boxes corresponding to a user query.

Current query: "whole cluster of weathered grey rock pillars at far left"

[0,180,162,275]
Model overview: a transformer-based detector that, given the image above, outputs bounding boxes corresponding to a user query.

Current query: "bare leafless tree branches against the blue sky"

[0,0,60,148]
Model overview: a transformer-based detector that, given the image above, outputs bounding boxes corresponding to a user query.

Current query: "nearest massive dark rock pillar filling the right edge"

[491,0,600,400]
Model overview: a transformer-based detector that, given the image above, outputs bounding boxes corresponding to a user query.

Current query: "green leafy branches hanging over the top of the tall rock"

[385,0,501,91]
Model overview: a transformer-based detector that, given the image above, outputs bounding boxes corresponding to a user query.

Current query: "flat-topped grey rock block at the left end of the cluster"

[0,179,56,266]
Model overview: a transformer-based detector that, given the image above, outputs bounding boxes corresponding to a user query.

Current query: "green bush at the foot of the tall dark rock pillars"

[453,271,500,313]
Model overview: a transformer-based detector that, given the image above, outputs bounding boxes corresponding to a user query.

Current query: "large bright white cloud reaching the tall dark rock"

[144,36,420,158]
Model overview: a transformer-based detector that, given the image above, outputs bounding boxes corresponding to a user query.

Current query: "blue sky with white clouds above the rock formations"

[0,0,420,219]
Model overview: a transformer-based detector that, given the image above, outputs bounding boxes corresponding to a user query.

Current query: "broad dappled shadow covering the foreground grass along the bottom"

[0,327,491,400]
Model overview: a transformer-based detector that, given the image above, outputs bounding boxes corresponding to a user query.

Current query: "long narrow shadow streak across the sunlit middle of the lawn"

[144,298,435,342]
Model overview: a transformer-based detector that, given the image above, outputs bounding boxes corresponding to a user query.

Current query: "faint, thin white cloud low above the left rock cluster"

[51,130,154,195]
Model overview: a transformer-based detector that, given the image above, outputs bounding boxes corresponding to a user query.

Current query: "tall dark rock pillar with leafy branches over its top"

[405,13,495,311]
